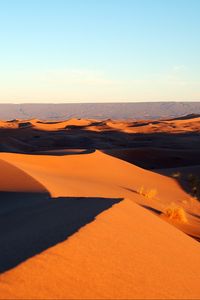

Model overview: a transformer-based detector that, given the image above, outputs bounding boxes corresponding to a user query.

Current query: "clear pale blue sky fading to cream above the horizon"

[0,0,200,103]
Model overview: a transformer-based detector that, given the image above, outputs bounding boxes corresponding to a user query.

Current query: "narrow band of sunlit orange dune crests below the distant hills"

[0,115,200,134]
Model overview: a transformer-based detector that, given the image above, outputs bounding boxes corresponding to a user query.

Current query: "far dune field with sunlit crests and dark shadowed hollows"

[0,117,200,169]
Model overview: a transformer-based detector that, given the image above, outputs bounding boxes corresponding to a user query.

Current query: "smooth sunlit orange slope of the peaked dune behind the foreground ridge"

[0,151,188,203]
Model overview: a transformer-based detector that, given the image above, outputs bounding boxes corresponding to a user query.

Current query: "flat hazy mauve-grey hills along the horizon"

[0,102,200,120]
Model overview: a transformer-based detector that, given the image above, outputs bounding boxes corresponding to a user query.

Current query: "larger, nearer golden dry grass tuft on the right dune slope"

[163,205,188,223]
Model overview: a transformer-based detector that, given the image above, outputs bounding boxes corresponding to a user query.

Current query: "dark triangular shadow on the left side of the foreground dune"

[0,192,123,272]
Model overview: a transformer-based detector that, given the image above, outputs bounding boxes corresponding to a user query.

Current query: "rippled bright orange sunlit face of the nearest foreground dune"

[0,200,200,299]
